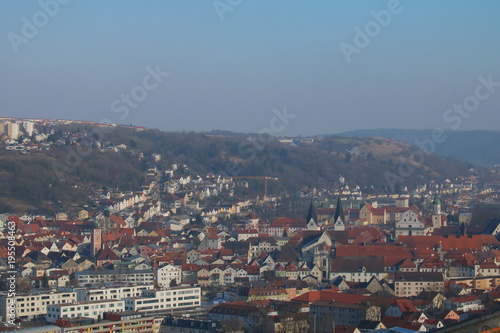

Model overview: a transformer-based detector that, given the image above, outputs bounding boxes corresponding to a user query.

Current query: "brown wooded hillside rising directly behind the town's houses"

[0,126,484,212]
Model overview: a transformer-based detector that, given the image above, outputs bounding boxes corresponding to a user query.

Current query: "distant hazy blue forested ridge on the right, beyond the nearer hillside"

[341,129,500,166]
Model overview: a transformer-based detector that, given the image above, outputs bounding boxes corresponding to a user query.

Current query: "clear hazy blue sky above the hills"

[0,0,500,135]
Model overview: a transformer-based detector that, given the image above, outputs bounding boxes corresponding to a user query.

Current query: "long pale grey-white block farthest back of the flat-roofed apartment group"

[75,269,153,286]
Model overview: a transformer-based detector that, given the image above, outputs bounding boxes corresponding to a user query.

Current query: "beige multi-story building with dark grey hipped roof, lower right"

[394,272,444,297]
